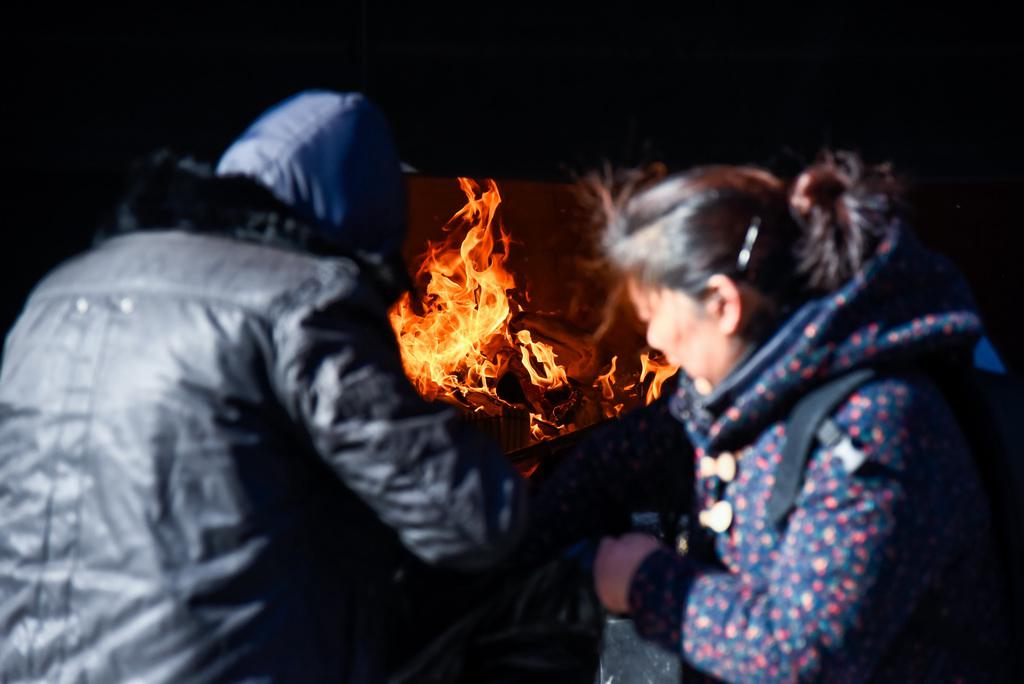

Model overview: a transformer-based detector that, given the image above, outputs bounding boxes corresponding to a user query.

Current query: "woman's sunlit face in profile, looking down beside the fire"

[627,279,741,386]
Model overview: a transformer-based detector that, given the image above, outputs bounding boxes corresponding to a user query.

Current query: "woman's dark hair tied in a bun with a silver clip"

[601,153,901,307]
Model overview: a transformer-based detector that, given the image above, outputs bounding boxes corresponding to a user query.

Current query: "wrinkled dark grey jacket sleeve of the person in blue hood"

[271,277,526,569]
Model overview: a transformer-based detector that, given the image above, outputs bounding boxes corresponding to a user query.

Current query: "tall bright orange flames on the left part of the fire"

[390,178,570,438]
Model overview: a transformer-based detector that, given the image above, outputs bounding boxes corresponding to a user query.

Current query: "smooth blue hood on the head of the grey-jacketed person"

[217,90,406,257]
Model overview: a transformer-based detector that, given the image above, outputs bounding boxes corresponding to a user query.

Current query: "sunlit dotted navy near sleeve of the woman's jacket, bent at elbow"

[630,380,986,681]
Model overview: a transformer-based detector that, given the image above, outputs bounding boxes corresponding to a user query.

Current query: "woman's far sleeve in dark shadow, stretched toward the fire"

[520,396,693,561]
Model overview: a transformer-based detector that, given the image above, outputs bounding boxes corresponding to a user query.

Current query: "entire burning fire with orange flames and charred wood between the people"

[390,178,676,445]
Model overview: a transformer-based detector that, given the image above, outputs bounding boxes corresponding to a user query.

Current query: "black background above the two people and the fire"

[0,0,1024,369]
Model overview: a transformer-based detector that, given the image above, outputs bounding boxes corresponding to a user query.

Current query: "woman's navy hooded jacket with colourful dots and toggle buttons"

[530,226,1009,682]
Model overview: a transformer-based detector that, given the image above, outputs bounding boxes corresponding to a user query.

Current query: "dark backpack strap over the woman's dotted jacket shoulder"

[767,369,876,527]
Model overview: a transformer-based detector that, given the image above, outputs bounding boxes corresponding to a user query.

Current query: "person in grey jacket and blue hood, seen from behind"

[0,91,526,682]
